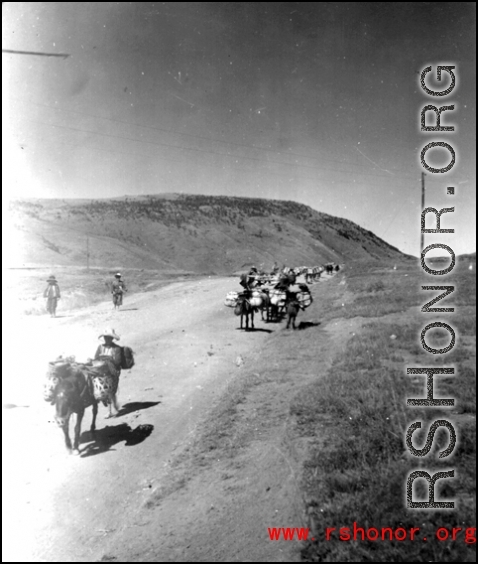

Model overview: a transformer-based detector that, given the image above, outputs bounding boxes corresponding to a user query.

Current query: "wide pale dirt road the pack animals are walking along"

[3,270,344,562]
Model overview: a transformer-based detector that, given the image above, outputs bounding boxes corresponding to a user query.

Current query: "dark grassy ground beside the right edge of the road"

[298,263,476,562]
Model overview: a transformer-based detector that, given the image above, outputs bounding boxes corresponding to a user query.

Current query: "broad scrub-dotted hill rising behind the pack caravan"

[7,194,403,273]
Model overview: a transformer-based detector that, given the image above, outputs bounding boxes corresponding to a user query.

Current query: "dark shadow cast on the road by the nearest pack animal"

[80,423,154,458]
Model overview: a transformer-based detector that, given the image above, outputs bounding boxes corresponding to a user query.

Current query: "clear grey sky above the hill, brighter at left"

[2,2,476,256]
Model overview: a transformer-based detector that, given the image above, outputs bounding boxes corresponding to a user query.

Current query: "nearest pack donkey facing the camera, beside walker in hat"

[54,365,98,454]
